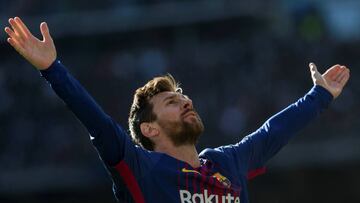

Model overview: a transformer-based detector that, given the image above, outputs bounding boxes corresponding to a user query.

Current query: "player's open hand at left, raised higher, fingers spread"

[5,17,56,70]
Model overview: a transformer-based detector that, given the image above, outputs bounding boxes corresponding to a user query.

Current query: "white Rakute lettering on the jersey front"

[179,190,240,203]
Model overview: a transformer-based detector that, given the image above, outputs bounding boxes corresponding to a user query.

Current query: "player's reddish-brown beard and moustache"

[158,113,204,147]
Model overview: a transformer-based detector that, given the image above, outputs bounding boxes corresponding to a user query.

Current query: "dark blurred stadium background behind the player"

[0,0,360,203]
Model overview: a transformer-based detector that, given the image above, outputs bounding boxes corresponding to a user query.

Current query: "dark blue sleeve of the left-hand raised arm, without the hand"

[41,61,134,165]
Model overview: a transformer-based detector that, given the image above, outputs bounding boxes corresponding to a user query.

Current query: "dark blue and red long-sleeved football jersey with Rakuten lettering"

[41,60,333,203]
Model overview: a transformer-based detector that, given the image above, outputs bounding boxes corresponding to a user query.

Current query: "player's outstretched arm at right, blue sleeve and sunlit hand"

[215,63,350,173]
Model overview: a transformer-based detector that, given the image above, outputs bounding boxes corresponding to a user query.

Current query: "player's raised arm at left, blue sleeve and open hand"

[5,17,132,165]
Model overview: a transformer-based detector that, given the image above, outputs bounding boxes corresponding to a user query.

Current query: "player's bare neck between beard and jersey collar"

[154,145,200,168]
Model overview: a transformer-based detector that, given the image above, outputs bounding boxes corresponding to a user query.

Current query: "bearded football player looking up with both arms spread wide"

[5,17,350,203]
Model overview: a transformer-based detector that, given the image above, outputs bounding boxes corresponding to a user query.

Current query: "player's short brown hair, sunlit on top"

[129,74,182,150]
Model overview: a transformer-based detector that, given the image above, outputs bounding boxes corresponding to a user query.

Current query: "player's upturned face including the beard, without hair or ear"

[150,92,204,146]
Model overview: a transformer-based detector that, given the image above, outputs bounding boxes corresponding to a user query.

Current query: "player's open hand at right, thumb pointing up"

[309,63,350,99]
